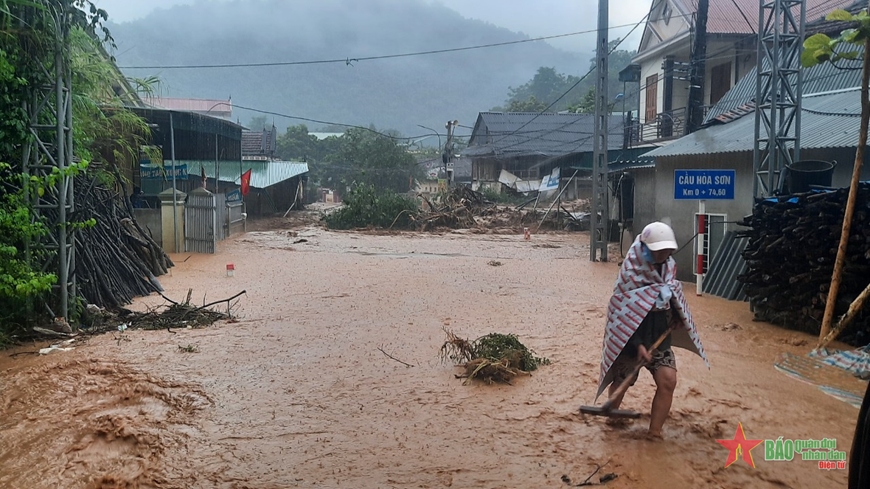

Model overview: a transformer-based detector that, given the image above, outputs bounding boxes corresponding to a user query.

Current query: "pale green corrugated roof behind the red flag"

[186,160,308,189]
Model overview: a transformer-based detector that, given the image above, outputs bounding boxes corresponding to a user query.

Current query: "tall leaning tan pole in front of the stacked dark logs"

[819,38,870,347]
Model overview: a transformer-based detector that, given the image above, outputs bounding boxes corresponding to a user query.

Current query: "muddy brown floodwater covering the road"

[0,219,857,489]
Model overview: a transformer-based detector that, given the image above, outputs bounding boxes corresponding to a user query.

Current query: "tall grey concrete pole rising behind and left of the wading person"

[589,0,610,261]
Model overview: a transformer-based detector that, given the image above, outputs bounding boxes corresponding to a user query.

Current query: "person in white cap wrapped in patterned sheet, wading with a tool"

[596,222,709,438]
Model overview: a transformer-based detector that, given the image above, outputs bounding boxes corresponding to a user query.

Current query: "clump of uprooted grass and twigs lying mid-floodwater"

[440,329,550,385]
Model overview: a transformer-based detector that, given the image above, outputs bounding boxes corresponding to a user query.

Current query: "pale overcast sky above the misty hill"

[94,0,652,53]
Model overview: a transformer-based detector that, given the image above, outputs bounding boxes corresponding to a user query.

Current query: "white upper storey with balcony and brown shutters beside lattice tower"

[621,0,866,147]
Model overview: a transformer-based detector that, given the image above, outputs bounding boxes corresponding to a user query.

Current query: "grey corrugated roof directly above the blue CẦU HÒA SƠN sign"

[644,89,861,157]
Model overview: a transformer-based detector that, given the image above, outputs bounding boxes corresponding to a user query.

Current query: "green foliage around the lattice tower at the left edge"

[0,0,148,334]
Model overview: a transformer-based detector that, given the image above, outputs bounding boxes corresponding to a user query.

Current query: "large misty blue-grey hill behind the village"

[109,0,589,135]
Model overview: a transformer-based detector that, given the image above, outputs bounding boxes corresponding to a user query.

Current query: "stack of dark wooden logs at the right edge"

[738,183,870,345]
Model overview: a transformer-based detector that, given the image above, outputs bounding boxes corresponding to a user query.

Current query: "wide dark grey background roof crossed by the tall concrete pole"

[463,112,623,156]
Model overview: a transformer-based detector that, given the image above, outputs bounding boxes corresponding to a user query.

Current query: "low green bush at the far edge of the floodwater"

[323,184,420,229]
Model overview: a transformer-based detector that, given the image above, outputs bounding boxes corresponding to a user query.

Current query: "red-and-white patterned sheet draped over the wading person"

[595,236,710,399]
